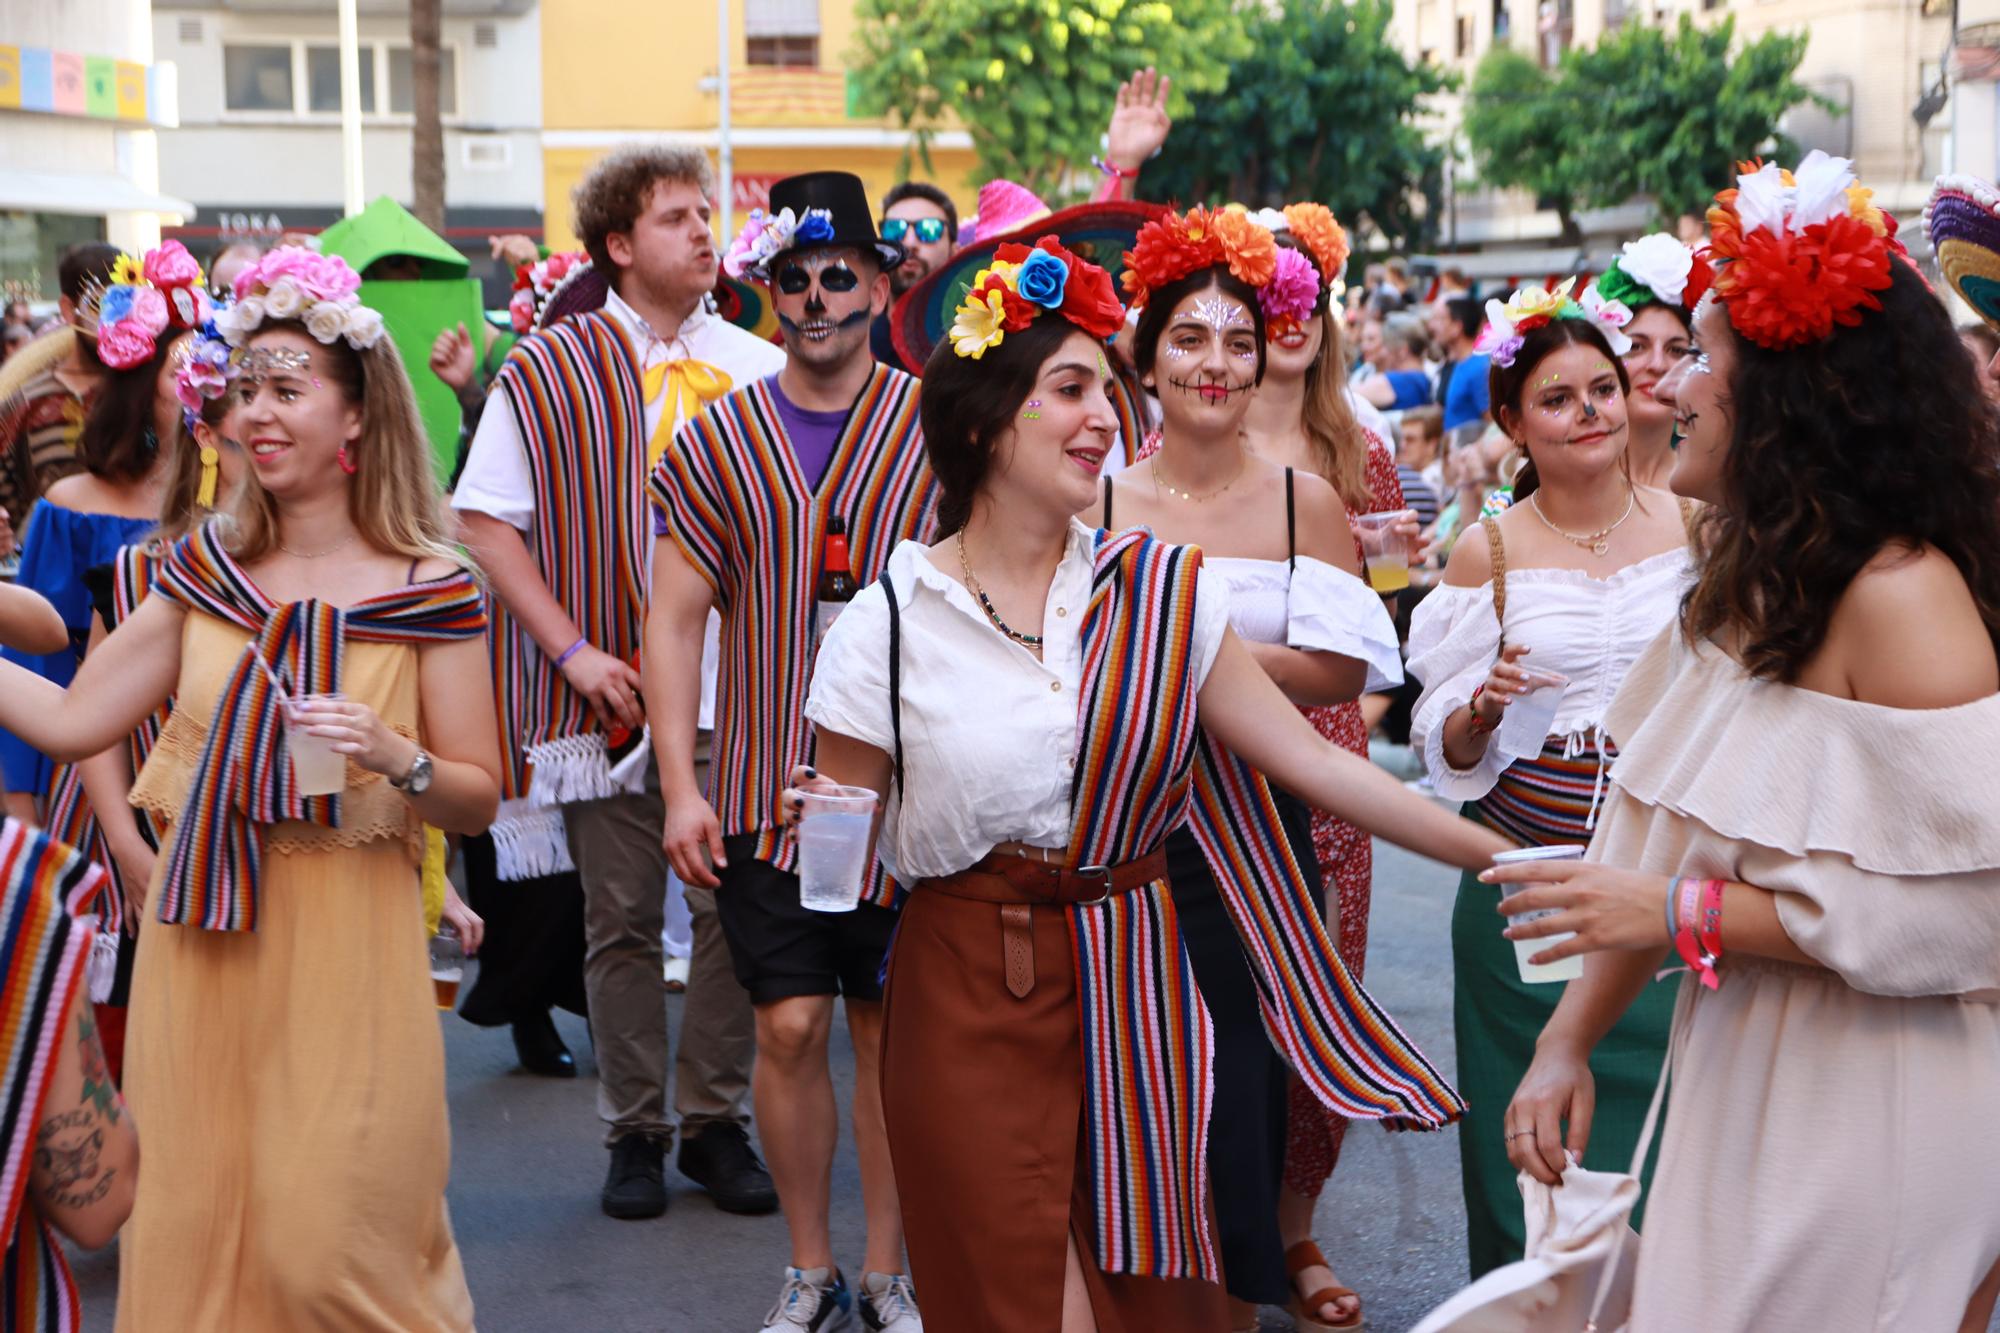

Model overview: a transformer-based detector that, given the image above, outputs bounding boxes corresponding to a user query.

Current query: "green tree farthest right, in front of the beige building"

[1464,14,1824,238]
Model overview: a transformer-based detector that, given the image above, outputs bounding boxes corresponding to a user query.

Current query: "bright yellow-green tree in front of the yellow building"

[848,0,1246,198]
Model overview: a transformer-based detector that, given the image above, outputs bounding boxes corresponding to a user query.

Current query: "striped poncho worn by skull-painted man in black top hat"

[650,366,936,905]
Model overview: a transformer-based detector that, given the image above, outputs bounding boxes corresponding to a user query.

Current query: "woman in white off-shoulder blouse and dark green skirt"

[1410,304,1690,1277]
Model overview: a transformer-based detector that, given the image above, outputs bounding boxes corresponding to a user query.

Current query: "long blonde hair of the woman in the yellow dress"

[230,320,464,564]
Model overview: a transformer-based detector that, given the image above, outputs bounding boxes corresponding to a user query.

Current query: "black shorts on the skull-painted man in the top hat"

[716,833,896,1005]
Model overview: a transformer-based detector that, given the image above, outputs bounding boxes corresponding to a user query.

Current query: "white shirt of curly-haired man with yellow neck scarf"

[452,292,784,729]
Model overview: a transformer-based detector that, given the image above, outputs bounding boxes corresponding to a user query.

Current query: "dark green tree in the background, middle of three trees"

[1140,0,1450,246]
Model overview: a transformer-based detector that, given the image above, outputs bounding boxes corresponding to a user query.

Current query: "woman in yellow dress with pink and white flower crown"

[0,248,498,1331]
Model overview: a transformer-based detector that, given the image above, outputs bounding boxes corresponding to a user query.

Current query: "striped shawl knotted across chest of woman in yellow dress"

[156,524,486,931]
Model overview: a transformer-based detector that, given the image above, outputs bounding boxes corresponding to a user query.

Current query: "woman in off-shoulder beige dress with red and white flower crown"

[1488,152,2000,1333]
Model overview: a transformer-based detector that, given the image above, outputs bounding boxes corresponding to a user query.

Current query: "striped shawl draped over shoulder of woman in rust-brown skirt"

[1070,530,1464,1281]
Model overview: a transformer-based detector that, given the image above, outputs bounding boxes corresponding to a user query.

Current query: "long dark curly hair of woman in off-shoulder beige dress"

[1680,260,2000,685]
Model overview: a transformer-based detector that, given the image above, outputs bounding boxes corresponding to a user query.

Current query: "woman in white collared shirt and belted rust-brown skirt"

[786,256,1504,1333]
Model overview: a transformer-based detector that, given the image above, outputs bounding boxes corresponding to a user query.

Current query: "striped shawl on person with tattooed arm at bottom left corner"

[0,819,106,1333]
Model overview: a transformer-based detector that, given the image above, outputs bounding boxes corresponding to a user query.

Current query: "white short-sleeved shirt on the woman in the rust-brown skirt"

[806,518,1230,885]
